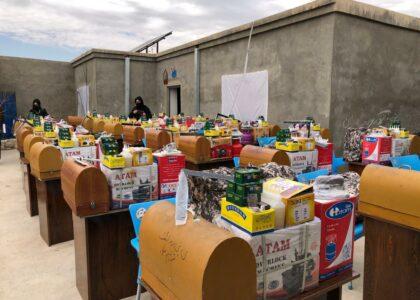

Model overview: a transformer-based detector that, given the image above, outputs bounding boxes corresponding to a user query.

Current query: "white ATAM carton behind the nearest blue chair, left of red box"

[101,164,159,209]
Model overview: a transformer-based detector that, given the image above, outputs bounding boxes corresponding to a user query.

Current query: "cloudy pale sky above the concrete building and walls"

[0,0,420,61]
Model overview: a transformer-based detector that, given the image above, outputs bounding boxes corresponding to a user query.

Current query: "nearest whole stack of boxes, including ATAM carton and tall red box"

[220,169,354,299]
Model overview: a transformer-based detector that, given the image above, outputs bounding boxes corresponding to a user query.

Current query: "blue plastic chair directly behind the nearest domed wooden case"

[128,198,175,300]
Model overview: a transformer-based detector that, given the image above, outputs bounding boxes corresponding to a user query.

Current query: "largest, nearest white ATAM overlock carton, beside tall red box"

[216,218,321,300]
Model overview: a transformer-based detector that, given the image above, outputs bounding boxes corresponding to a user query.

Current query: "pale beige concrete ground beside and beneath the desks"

[0,150,364,300]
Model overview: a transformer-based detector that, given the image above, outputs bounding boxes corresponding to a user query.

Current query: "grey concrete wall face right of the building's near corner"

[330,14,420,148]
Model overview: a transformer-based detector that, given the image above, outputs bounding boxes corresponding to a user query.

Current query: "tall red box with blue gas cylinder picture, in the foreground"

[315,197,357,281]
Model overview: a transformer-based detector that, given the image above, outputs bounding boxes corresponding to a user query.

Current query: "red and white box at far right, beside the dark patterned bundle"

[362,135,392,163]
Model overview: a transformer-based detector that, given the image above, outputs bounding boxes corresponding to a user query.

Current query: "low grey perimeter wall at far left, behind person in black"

[0,56,76,117]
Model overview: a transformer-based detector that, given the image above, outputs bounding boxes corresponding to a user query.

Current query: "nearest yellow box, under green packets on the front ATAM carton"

[220,198,274,235]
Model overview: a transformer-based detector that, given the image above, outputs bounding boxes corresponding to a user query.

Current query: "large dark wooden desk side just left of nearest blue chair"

[73,211,138,300]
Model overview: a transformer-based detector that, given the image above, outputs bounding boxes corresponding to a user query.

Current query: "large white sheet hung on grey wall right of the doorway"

[222,71,268,121]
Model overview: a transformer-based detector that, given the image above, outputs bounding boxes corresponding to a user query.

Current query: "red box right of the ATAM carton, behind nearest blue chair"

[154,154,185,199]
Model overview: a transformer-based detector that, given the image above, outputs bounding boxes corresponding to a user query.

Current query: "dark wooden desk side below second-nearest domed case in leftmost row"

[36,179,73,246]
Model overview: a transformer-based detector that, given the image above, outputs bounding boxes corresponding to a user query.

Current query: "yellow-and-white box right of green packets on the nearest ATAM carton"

[263,177,314,227]
